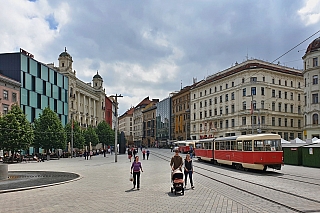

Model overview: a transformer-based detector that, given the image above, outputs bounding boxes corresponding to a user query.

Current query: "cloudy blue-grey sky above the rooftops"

[0,0,320,114]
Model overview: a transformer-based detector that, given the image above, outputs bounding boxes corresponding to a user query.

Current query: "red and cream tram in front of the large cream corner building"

[195,133,283,170]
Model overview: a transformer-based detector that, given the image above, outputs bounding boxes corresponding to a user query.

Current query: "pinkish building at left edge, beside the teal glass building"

[0,74,21,114]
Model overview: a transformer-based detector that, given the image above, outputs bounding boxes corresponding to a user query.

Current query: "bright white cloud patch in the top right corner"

[298,0,320,26]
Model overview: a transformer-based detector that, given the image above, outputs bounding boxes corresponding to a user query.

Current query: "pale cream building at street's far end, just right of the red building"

[118,107,134,145]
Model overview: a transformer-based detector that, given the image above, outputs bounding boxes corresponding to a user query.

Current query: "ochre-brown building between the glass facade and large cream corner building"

[171,85,194,140]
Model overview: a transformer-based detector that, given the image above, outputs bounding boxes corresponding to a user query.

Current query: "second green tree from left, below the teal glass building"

[34,107,67,151]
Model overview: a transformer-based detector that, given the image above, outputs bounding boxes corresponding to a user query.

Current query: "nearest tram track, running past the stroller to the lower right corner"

[154,150,320,213]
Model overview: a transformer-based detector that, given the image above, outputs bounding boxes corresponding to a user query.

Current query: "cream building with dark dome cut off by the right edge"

[302,37,320,140]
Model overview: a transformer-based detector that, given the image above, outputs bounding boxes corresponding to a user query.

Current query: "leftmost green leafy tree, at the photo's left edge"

[0,104,34,158]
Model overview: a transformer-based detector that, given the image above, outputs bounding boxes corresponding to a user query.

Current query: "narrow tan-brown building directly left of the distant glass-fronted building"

[142,101,157,147]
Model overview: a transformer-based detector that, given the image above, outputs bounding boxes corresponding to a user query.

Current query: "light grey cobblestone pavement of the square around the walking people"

[0,149,318,213]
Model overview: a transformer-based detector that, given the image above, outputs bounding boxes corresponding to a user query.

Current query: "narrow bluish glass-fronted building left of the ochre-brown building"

[156,97,171,142]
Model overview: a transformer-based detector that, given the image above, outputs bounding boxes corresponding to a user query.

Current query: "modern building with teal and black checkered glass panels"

[0,50,69,126]
